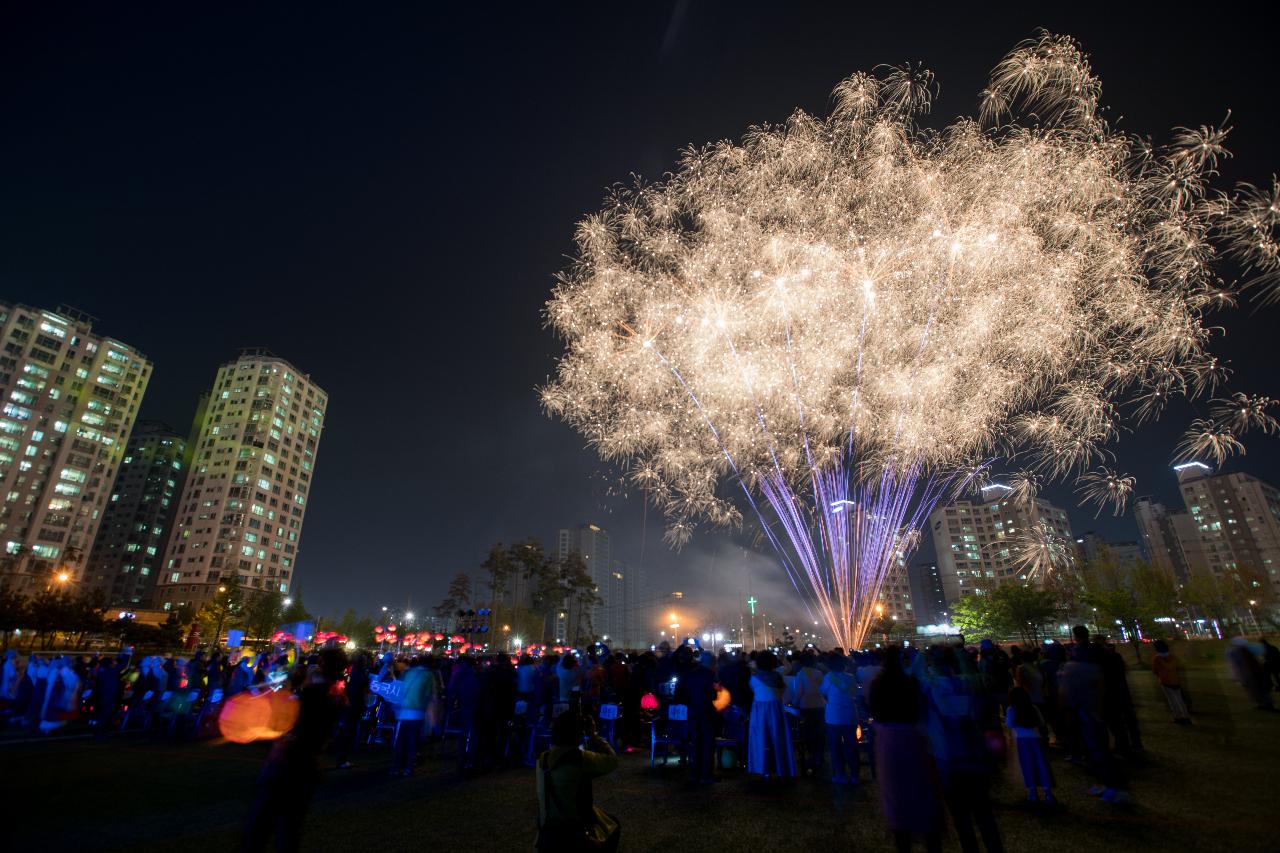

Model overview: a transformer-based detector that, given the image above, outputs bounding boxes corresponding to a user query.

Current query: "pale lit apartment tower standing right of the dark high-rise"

[156,350,329,610]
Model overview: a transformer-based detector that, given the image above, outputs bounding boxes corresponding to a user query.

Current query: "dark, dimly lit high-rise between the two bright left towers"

[84,420,187,607]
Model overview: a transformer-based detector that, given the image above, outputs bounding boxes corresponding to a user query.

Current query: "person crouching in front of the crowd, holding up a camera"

[534,711,621,853]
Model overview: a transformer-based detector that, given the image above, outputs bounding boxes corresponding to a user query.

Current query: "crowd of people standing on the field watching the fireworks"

[0,626,1280,850]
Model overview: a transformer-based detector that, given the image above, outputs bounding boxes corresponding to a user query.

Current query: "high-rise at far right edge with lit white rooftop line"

[1174,462,1280,587]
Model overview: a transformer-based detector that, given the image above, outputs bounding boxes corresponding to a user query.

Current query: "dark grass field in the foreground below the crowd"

[0,651,1280,853]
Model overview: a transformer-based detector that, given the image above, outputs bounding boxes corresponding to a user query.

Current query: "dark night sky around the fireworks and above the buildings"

[0,3,1280,627]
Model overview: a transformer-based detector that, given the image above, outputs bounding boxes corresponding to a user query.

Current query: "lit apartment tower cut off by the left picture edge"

[0,302,151,592]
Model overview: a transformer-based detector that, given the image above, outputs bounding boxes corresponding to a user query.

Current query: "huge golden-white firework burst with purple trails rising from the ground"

[543,35,1277,647]
